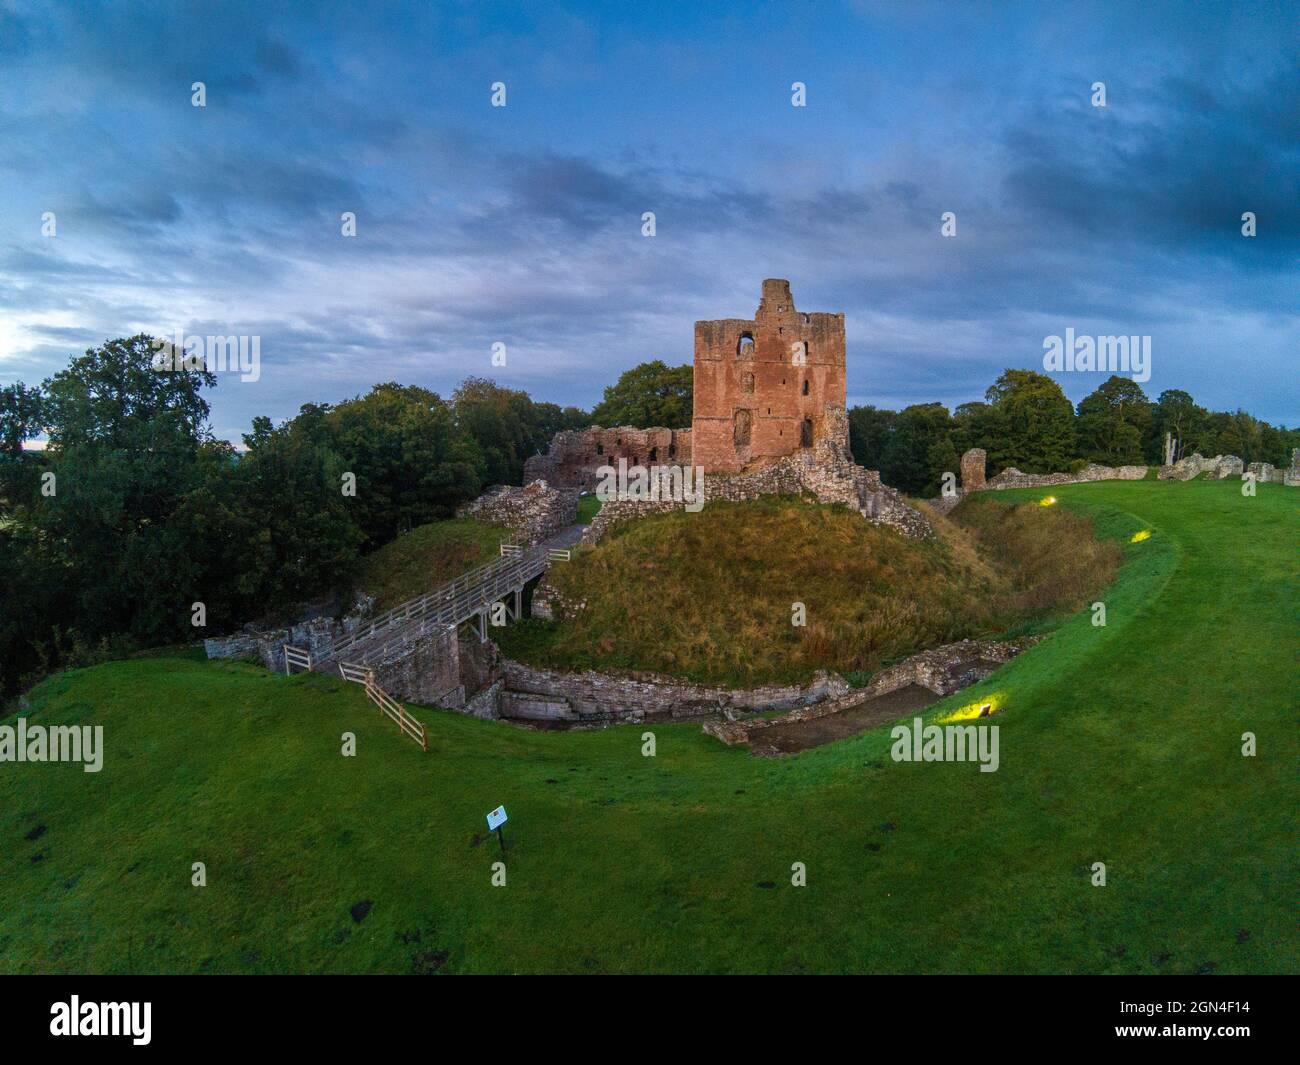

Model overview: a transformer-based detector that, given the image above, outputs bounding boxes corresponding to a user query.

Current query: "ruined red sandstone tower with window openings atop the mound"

[690,278,849,473]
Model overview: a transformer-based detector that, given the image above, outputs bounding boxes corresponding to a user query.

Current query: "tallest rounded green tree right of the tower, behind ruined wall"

[984,369,1076,473]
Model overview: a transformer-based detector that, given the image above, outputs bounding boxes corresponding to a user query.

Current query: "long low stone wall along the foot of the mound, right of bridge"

[488,659,849,722]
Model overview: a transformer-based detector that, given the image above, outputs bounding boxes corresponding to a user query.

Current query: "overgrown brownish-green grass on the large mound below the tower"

[497,497,1118,687]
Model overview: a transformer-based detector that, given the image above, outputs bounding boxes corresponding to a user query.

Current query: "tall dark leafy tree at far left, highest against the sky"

[29,335,216,642]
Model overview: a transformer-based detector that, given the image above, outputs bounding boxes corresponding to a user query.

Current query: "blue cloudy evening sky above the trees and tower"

[0,0,1300,440]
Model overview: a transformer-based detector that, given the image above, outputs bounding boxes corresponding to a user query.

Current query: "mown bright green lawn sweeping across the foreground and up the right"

[0,481,1300,973]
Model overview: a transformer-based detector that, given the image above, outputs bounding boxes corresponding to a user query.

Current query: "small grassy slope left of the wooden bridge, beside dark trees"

[356,518,512,610]
